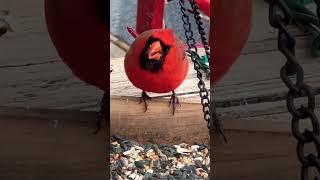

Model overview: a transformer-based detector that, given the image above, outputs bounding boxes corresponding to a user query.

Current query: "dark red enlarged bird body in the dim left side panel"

[45,0,110,91]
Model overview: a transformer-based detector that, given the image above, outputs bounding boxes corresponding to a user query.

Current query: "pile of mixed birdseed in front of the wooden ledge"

[110,135,210,180]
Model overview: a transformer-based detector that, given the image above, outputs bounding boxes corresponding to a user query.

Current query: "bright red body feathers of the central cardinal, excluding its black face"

[124,29,189,93]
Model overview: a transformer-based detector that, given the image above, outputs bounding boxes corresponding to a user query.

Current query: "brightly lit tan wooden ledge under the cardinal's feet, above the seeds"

[110,96,209,144]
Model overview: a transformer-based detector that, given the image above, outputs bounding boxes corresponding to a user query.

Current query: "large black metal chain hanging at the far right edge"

[269,0,320,180]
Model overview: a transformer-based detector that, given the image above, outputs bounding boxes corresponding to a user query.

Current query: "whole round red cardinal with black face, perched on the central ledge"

[124,29,189,114]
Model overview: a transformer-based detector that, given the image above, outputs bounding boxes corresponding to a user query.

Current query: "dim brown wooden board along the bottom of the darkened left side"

[0,108,108,180]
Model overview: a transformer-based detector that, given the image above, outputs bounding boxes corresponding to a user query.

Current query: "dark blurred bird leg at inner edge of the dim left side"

[94,93,109,134]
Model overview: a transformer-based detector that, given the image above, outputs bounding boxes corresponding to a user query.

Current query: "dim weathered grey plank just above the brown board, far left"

[0,61,102,109]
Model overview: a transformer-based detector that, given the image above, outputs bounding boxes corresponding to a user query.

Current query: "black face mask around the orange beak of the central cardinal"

[140,36,170,72]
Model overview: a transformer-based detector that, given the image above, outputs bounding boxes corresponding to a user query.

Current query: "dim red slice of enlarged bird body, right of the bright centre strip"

[209,0,252,85]
